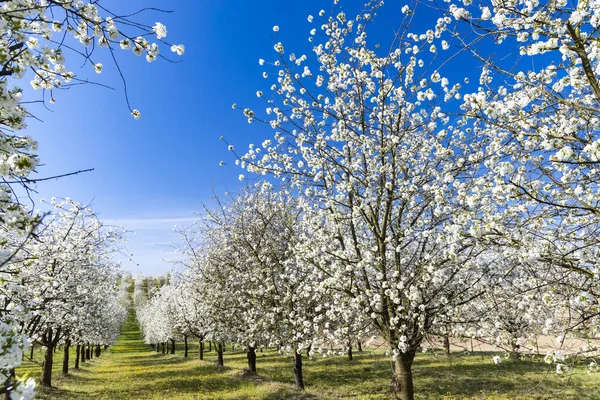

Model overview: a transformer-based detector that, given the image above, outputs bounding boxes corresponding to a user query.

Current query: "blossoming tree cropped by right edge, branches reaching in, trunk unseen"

[440,1,600,356]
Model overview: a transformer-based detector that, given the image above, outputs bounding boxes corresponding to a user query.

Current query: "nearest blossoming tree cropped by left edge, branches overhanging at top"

[0,0,184,398]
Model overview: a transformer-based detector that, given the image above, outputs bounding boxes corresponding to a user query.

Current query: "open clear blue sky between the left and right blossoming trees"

[23,0,454,274]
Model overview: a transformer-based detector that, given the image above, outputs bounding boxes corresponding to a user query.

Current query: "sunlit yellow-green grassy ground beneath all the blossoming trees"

[18,315,600,400]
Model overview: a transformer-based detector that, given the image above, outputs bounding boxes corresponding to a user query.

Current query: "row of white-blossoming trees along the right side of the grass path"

[142,0,600,399]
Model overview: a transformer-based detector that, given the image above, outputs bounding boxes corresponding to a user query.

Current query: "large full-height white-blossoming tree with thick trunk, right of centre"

[230,2,501,399]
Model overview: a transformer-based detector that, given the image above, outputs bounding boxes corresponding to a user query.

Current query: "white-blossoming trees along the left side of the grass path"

[0,0,184,399]
